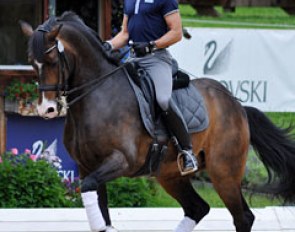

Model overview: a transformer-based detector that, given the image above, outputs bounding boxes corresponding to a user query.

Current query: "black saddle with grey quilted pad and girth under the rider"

[125,60,209,176]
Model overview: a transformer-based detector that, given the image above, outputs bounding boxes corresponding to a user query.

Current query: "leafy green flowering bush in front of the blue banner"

[0,152,73,208]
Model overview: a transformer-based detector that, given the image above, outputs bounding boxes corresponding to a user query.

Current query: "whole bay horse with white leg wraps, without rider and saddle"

[21,12,295,232]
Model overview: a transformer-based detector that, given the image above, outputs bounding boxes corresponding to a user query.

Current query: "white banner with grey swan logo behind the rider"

[169,28,295,112]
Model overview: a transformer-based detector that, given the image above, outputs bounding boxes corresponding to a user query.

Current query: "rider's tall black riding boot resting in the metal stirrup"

[163,100,198,175]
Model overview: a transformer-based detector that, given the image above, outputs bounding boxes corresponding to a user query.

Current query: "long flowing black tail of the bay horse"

[244,107,295,201]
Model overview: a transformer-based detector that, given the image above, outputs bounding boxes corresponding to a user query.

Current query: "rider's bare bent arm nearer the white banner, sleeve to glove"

[155,11,182,48]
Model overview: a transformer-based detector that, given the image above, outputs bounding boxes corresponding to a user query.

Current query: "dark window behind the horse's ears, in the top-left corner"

[0,0,43,65]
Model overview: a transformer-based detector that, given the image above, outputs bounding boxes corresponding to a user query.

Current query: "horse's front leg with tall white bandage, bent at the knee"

[81,150,128,232]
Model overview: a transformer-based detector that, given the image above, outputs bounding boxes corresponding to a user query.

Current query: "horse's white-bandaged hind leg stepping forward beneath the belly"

[158,177,210,232]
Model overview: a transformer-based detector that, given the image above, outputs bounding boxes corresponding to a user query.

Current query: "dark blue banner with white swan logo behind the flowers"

[6,114,78,181]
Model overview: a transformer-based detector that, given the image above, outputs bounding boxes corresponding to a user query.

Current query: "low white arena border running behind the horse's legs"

[0,207,295,232]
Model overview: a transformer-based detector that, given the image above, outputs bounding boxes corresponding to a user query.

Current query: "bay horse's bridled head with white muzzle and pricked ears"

[20,19,69,118]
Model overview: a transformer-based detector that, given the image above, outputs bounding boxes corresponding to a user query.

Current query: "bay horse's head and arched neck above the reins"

[20,12,113,118]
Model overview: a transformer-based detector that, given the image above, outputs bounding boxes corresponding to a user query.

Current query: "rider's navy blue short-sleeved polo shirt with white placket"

[124,0,178,42]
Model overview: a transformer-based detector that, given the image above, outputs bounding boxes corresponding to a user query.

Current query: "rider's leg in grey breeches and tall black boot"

[139,51,197,175]
